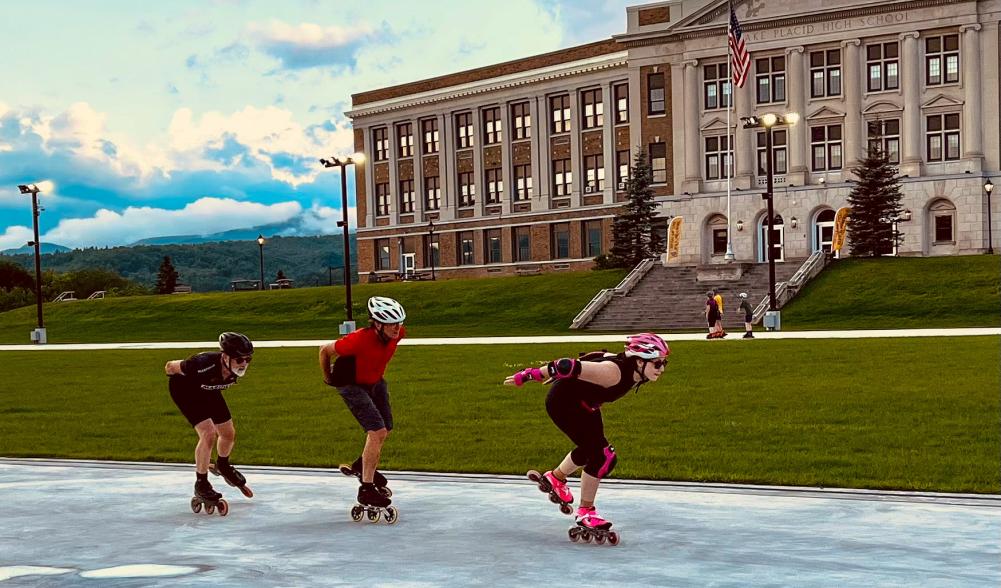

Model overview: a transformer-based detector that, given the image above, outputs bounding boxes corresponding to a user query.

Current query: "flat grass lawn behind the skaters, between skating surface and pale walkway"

[0,336,1001,493]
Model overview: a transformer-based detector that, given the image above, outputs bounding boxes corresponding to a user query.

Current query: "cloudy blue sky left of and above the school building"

[0,0,642,250]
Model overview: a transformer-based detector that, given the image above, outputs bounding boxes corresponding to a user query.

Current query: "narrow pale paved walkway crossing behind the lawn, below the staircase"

[0,328,1001,352]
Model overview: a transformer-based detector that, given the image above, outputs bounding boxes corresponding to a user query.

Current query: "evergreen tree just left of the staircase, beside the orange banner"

[612,149,664,267]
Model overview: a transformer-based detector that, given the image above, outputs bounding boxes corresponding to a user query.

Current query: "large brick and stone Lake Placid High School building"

[349,0,1001,277]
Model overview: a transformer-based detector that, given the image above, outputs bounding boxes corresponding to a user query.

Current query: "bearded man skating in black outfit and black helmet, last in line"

[163,332,253,508]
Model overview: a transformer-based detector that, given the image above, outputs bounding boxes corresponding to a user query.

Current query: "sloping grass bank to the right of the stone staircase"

[782,255,1001,331]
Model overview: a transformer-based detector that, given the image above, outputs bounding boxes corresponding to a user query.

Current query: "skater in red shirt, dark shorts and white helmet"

[319,297,406,508]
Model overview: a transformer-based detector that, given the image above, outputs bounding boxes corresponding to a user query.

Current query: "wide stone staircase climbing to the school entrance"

[584,259,804,333]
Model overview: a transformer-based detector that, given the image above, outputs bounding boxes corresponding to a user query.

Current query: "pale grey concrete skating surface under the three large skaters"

[0,459,1001,588]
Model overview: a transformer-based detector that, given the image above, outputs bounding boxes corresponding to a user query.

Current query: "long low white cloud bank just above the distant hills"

[42,197,302,247]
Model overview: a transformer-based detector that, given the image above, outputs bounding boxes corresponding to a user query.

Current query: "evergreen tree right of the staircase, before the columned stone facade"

[848,121,903,257]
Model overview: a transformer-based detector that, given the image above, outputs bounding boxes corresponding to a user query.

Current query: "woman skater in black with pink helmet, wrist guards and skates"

[505,333,671,538]
